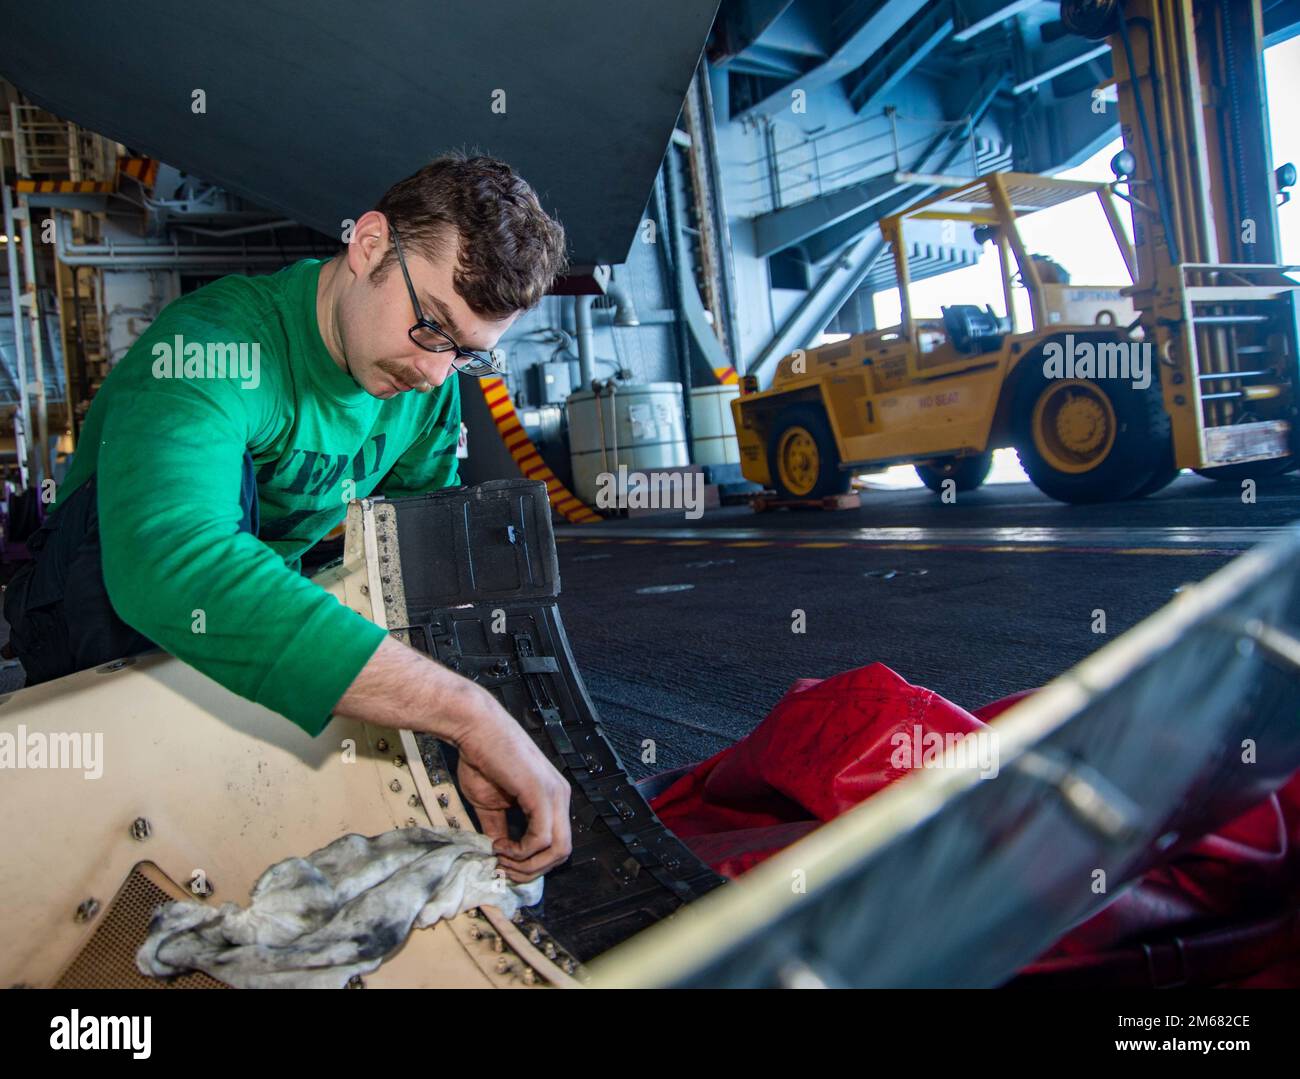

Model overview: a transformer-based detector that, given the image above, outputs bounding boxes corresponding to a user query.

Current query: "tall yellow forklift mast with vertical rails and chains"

[1061,0,1300,468]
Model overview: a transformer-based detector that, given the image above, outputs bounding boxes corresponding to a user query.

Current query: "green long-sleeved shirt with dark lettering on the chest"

[55,259,460,735]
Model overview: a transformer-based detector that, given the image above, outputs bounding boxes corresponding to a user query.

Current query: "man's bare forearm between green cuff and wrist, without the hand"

[334,637,494,745]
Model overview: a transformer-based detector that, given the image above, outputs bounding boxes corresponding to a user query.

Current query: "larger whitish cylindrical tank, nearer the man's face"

[564,382,690,506]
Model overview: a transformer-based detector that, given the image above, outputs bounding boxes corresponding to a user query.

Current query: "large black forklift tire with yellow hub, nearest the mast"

[1011,354,1177,503]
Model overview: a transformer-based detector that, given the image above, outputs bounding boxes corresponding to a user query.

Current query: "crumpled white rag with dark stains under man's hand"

[135,828,542,989]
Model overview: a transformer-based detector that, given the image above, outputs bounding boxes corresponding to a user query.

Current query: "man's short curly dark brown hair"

[371,151,568,319]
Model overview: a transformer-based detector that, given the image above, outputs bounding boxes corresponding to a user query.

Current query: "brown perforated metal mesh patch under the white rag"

[53,862,230,989]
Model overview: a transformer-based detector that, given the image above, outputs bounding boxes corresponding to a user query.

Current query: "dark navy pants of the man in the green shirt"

[4,452,259,685]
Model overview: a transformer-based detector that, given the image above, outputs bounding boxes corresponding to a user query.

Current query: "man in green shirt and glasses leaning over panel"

[5,153,571,880]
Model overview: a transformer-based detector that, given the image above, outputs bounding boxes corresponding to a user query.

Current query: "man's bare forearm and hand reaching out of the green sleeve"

[334,638,573,881]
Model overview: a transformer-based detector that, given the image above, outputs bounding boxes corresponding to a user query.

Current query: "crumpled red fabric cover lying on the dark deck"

[653,663,1300,984]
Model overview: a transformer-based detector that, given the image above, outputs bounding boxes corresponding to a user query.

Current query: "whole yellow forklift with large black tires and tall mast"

[732,0,1300,502]
